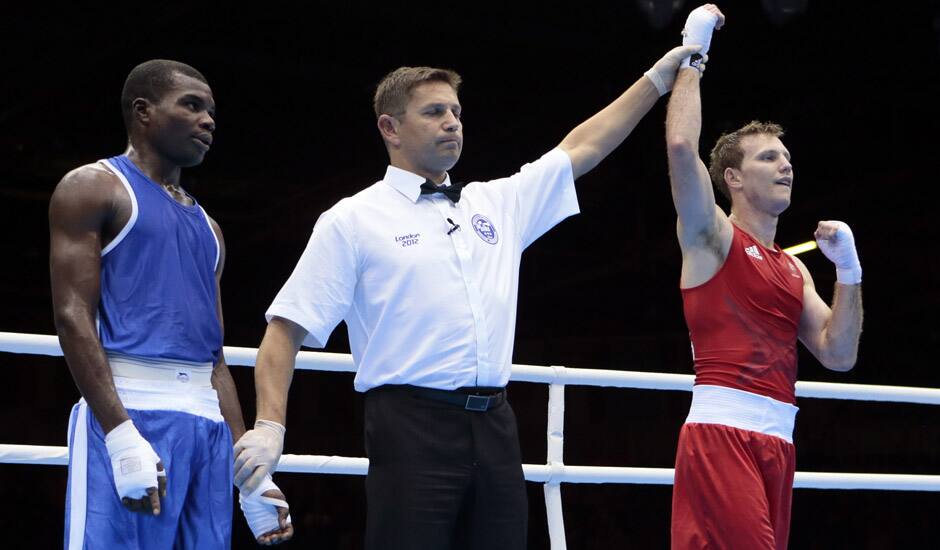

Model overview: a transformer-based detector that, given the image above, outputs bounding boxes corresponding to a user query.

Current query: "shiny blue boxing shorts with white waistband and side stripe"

[64,355,232,550]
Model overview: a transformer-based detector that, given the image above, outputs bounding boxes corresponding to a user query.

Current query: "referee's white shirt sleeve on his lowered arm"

[265,207,358,348]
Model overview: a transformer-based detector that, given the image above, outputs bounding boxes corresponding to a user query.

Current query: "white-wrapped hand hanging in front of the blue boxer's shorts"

[104,420,166,499]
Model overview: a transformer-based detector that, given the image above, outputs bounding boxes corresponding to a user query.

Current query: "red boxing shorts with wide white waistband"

[671,386,797,550]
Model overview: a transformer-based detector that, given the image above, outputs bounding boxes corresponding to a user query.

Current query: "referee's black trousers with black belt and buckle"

[365,386,528,550]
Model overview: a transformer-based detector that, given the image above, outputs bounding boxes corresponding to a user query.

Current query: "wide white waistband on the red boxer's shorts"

[685,386,800,443]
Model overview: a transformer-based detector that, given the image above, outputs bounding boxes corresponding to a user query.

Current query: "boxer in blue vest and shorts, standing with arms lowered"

[49,60,293,550]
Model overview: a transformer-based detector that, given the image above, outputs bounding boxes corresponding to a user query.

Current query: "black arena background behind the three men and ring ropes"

[0,0,940,549]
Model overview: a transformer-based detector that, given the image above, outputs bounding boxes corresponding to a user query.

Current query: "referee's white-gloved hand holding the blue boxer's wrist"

[234,420,286,494]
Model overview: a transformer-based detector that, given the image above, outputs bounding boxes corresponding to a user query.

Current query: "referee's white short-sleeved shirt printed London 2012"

[266,148,579,391]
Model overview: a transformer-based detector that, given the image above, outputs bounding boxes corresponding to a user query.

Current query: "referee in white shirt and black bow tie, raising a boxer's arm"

[235,47,698,550]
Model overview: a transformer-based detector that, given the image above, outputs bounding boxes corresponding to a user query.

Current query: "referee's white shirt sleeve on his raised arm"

[509,148,581,247]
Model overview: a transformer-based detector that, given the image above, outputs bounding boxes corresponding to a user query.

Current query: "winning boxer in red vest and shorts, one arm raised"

[666,4,862,550]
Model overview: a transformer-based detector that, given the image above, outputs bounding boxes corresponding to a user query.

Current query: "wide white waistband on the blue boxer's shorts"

[108,354,223,422]
